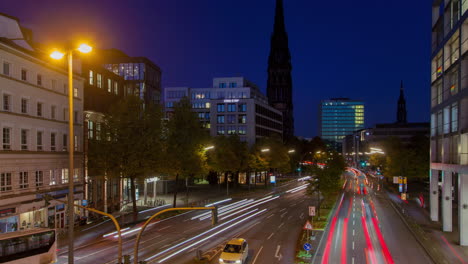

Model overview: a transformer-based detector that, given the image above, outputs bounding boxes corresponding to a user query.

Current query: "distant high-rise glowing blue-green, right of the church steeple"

[319,98,364,151]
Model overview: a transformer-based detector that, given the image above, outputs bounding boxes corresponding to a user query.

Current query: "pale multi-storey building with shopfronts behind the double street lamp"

[0,14,84,233]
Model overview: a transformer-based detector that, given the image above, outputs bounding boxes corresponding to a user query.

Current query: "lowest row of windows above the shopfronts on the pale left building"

[0,168,80,192]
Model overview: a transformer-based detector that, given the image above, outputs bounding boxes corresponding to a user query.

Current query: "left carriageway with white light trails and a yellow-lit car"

[58,177,314,264]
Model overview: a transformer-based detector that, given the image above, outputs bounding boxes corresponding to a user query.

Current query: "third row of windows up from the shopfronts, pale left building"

[1,93,81,123]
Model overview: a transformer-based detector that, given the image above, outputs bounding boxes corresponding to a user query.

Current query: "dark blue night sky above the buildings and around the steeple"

[0,0,431,137]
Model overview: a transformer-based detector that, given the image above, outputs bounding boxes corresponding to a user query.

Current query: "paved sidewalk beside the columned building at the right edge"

[386,190,468,264]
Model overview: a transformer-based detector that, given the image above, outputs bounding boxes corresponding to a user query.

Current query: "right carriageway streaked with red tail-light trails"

[313,170,432,264]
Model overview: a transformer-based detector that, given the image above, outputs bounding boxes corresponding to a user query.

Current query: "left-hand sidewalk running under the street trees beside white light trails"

[57,178,295,251]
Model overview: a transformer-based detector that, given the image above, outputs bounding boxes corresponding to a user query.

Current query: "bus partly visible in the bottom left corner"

[0,228,57,264]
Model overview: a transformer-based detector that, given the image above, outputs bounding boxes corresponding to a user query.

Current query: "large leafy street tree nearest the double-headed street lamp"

[88,96,163,221]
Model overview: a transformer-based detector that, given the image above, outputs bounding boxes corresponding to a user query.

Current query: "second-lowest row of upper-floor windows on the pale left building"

[2,127,79,151]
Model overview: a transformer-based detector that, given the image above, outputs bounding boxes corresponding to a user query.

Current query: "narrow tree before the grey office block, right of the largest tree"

[164,97,208,207]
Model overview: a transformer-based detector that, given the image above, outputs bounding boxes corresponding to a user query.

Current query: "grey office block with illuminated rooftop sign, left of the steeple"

[164,77,283,145]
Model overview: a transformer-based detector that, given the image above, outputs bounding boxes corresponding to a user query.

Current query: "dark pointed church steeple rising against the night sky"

[267,0,294,139]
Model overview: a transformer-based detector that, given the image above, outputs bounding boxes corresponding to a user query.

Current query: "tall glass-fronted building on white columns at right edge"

[430,0,468,246]
